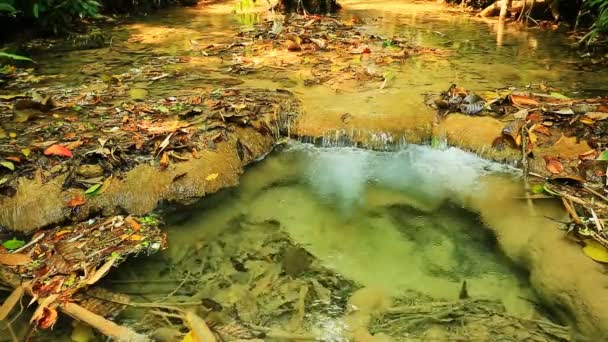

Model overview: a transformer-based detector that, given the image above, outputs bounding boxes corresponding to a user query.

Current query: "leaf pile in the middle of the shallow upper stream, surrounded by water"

[202,15,440,87]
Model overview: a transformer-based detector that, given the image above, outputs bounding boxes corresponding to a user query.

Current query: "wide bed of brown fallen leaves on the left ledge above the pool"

[0,70,299,200]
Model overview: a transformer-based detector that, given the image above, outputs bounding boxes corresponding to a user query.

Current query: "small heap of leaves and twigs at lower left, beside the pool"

[0,216,166,328]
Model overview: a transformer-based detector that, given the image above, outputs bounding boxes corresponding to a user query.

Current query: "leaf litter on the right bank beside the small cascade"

[427,84,608,262]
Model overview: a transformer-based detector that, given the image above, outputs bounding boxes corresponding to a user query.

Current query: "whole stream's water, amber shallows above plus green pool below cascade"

[13,0,608,340]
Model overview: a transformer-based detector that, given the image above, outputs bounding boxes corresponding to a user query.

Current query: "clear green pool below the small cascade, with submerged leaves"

[98,143,540,341]
